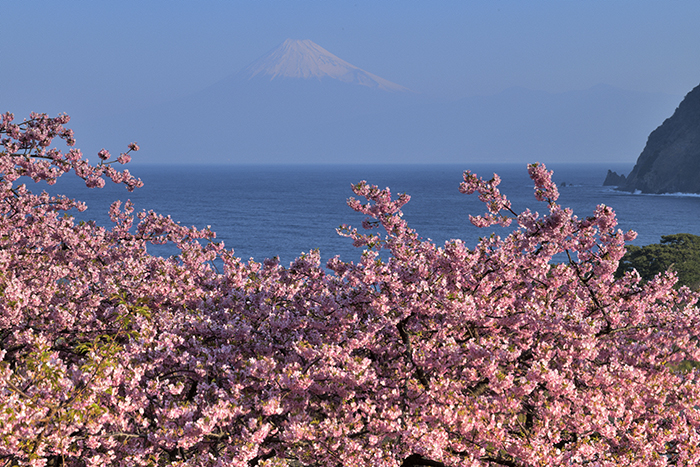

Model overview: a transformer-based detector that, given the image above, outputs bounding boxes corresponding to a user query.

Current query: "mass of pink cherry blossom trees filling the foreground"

[0,115,700,467]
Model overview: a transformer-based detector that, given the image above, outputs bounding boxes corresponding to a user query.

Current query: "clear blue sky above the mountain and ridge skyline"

[5,0,700,116]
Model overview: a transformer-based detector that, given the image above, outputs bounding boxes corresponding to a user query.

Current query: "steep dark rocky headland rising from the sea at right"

[618,86,700,193]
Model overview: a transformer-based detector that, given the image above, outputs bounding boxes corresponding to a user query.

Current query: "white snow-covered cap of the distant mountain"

[241,39,408,92]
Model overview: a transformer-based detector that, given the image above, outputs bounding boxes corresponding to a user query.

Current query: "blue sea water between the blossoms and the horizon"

[39,164,700,264]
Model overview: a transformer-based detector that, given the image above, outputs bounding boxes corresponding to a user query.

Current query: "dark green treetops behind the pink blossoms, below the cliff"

[617,233,700,289]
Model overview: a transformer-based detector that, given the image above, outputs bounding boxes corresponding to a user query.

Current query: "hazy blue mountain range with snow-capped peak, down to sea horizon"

[76,39,678,166]
